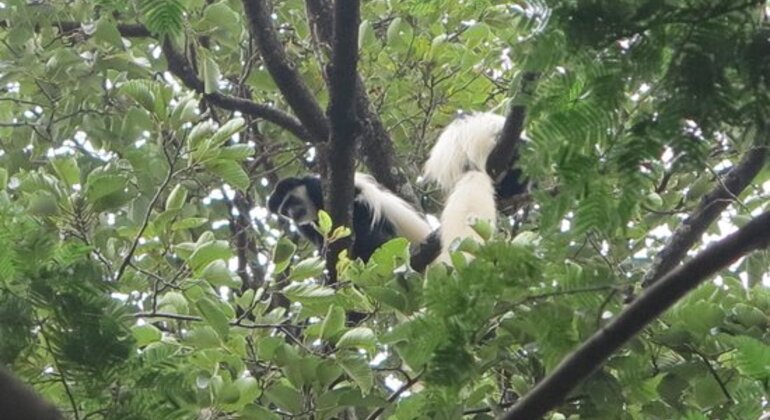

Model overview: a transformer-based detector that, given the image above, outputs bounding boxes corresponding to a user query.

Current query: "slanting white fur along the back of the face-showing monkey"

[354,172,431,243]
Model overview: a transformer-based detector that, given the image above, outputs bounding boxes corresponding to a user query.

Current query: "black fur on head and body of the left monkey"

[267,176,397,261]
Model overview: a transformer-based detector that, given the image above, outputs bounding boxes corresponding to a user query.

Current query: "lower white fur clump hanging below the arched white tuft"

[437,171,497,264]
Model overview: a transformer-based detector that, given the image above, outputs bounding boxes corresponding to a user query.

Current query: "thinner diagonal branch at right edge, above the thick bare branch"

[642,140,767,286]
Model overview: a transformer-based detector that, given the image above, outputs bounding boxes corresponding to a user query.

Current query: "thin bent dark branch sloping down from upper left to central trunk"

[162,39,315,142]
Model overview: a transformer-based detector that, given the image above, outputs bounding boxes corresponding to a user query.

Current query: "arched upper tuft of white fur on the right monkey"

[423,112,505,194]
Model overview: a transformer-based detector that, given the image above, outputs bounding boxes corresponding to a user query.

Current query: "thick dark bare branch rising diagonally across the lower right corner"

[504,208,770,420]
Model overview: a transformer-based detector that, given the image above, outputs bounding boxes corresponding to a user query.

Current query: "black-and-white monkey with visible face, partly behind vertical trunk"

[267,173,431,261]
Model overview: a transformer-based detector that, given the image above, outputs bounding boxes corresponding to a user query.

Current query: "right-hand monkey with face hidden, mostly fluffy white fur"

[423,112,527,263]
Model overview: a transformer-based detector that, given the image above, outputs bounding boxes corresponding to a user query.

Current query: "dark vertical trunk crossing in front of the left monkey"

[325,0,360,282]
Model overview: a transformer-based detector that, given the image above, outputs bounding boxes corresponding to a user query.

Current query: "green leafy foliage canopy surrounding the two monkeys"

[0,0,770,419]
